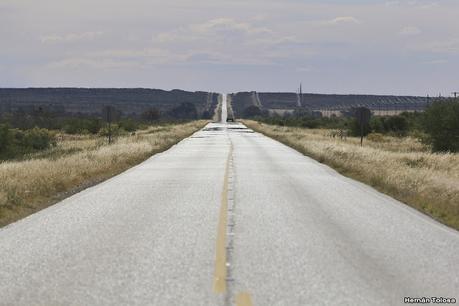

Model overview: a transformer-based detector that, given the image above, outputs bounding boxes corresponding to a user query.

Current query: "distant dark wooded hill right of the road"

[232,92,429,117]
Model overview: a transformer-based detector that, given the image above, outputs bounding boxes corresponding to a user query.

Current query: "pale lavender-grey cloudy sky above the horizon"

[0,0,459,95]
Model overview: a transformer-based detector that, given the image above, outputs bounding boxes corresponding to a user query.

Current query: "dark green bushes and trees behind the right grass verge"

[255,99,459,152]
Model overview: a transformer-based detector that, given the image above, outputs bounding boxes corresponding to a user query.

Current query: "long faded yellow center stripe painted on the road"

[214,144,233,293]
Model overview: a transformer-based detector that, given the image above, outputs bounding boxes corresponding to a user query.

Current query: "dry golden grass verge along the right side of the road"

[244,120,459,229]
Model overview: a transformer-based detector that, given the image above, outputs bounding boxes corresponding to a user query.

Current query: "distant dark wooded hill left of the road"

[0,88,218,116]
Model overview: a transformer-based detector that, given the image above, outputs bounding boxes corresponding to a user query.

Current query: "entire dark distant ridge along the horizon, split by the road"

[0,88,429,118]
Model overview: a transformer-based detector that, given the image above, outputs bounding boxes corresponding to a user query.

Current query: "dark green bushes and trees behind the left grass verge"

[0,102,210,160]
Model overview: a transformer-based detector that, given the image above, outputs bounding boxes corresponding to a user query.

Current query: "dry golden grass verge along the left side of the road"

[0,121,206,226]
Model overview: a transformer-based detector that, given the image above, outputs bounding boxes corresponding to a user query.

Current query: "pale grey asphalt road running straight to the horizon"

[0,106,459,305]
